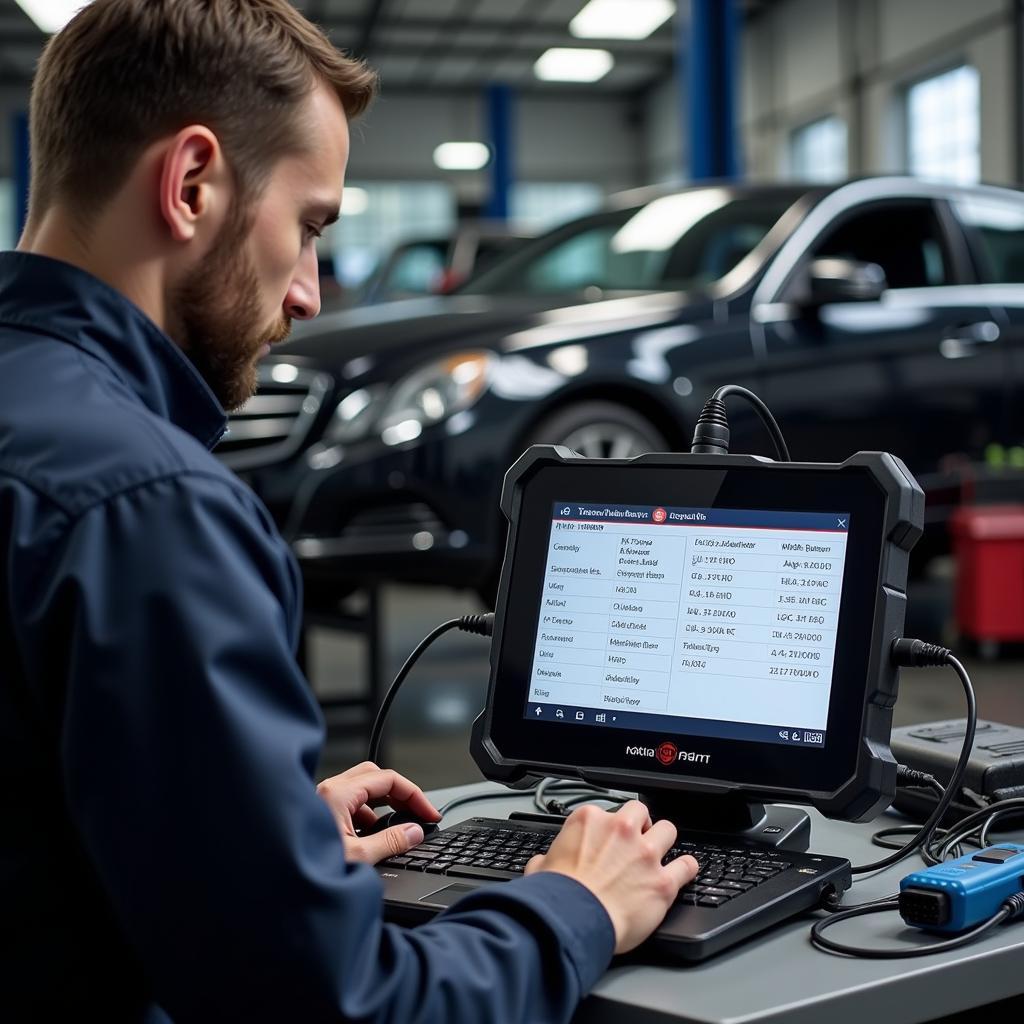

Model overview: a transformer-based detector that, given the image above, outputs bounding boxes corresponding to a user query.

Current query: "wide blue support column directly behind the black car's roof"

[676,0,740,181]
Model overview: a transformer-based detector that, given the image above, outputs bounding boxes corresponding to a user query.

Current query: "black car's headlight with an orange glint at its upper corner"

[378,351,496,444]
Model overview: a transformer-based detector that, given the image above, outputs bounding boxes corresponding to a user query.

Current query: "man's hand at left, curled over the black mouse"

[316,761,441,864]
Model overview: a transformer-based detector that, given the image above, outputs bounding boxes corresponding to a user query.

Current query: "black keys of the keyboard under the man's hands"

[380,822,793,907]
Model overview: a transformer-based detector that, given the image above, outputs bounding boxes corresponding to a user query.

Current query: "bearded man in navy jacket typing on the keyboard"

[0,0,696,1022]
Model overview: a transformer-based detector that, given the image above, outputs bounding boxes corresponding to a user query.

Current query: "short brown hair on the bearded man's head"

[30,0,377,222]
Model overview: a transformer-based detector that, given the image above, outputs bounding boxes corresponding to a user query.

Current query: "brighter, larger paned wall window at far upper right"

[906,65,981,184]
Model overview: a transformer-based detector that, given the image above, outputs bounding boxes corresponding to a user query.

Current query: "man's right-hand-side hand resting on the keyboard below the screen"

[526,800,697,953]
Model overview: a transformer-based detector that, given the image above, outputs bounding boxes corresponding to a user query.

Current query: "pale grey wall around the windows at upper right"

[740,0,1021,182]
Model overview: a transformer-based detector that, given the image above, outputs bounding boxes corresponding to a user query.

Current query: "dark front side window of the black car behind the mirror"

[811,200,953,288]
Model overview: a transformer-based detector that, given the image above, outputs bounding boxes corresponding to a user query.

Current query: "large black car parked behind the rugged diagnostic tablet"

[220,178,1024,604]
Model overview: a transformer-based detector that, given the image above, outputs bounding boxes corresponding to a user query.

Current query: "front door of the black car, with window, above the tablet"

[753,194,1006,489]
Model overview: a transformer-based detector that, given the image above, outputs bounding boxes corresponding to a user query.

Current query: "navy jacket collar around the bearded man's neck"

[0,252,227,449]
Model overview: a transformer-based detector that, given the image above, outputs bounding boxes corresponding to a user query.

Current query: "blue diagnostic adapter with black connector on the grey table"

[899,843,1024,932]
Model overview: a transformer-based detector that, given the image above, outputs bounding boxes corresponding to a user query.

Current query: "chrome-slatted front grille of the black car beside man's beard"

[216,362,332,470]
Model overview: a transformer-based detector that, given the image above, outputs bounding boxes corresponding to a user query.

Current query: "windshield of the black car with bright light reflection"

[462,188,796,295]
